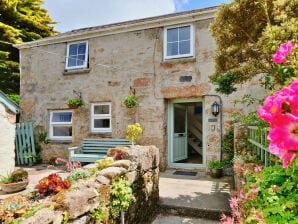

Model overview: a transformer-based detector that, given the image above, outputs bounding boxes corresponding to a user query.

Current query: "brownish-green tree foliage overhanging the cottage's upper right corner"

[210,0,298,94]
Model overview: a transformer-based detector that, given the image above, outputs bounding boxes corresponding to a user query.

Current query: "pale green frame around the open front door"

[167,98,206,169]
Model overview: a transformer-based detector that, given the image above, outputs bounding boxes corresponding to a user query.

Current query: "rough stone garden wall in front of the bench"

[1,146,159,224]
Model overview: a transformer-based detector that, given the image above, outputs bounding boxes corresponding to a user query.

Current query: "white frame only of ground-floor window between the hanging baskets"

[91,102,112,133]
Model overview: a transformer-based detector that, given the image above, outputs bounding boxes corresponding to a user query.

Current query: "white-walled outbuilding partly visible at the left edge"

[0,90,19,175]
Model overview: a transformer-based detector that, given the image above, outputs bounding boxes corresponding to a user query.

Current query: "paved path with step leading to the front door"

[153,170,232,224]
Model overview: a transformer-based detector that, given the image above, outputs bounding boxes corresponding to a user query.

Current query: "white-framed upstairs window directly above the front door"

[164,25,194,59]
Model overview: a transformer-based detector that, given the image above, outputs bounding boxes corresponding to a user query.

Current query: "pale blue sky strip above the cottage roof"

[43,0,231,32]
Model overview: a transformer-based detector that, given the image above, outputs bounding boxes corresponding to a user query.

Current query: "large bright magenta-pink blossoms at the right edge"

[258,42,298,168]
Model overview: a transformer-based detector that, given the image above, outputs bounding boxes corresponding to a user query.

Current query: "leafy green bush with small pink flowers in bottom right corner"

[220,165,298,224]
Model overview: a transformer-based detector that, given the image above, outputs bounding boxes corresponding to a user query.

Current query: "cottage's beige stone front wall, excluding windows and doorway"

[15,8,266,170]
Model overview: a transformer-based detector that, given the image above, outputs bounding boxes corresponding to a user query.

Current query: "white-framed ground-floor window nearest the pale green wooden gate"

[50,110,72,140]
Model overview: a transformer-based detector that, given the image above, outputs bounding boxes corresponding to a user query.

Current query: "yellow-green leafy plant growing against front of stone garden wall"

[111,177,136,218]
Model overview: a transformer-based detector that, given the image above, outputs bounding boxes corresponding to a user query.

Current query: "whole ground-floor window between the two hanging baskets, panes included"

[91,103,112,132]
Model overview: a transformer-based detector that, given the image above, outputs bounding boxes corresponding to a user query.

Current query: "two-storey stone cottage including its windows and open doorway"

[16,7,264,170]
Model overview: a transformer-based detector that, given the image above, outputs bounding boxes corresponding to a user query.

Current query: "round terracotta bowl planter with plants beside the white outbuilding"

[0,169,29,193]
